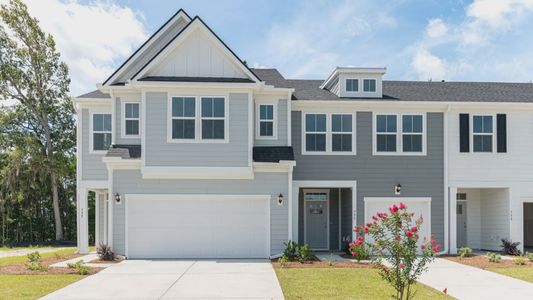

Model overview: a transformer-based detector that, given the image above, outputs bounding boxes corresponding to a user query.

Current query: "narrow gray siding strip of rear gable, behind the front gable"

[115,20,187,82]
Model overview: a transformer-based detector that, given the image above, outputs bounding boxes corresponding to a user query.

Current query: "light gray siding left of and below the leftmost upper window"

[81,109,107,180]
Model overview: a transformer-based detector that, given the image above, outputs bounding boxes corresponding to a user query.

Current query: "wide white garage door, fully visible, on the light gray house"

[126,195,270,258]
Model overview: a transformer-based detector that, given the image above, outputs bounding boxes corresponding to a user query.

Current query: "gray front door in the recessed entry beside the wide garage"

[304,190,329,250]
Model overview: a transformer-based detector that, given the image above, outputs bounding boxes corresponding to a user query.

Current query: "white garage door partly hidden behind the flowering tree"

[365,197,431,241]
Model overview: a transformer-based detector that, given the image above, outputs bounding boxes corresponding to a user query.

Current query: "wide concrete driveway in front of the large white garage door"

[42,260,283,299]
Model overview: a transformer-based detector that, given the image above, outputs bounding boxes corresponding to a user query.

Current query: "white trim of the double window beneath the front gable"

[167,95,230,144]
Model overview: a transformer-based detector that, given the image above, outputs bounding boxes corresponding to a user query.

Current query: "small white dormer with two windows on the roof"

[320,67,387,98]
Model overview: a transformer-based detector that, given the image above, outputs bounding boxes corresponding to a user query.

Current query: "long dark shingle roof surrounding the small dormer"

[250,69,533,103]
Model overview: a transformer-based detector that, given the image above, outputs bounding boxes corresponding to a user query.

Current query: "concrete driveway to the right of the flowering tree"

[419,258,533,300]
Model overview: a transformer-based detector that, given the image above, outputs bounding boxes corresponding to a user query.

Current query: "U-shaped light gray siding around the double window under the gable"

[144,92,249,167]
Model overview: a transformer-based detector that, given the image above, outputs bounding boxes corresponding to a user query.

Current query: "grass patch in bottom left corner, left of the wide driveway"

[0,275,85,299]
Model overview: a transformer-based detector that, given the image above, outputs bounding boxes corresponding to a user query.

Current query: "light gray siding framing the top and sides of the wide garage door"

[113,170,289,255]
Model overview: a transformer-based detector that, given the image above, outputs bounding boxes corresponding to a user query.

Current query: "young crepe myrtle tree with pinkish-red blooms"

[354,203,440,300]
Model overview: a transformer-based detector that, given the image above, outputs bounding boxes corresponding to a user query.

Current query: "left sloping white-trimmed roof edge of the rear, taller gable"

[103,9,191,85]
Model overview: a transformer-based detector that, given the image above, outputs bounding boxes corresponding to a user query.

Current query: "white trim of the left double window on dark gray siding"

[301,111,357,155]
